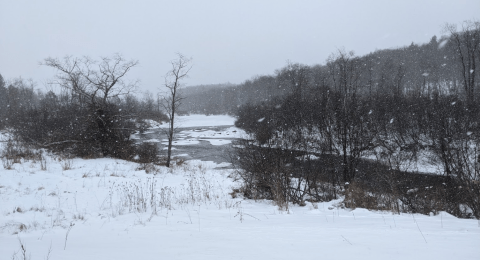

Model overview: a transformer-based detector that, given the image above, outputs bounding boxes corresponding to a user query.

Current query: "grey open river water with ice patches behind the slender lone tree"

[134,125,236,163]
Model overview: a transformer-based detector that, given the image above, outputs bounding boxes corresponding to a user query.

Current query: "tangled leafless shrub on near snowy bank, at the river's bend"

[231,140,341,210]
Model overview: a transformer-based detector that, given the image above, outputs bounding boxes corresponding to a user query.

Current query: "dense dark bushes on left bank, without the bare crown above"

[0,79,165,162]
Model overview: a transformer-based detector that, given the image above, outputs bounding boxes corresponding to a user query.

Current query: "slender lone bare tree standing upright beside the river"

[161,53,192,167]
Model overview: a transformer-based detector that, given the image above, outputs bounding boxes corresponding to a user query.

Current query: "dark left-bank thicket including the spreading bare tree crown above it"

[0,55,165,159]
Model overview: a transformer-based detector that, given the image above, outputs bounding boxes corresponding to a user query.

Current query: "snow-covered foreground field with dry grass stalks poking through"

[0,116,480,260]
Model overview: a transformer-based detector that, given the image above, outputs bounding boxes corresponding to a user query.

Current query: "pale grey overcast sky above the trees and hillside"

[0,0,480,92]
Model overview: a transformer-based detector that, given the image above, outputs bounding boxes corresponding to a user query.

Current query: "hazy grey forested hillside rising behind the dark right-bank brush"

[182,29,479,115]
